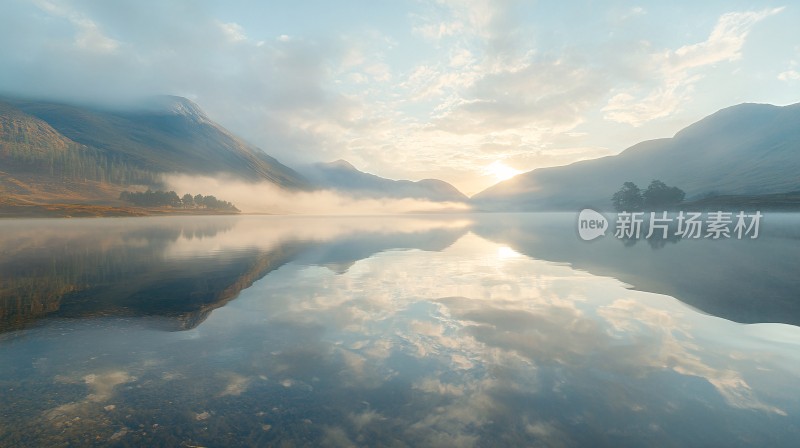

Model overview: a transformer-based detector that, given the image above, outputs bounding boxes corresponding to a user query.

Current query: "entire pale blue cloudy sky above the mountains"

[0,0,800,195]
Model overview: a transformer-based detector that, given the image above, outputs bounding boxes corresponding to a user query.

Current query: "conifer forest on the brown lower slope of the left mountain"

[0,142,158,185]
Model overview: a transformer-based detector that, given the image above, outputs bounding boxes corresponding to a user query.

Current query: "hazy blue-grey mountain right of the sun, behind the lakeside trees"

[472,103,800,211]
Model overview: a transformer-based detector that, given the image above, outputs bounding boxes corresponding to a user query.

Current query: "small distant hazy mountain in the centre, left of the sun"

[300,160,469,202]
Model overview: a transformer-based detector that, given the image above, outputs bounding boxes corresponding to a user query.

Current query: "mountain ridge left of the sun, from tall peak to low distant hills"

[0,95,468,214]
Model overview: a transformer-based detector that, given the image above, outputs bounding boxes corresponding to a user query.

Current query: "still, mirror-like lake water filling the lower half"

[0,214,800,447]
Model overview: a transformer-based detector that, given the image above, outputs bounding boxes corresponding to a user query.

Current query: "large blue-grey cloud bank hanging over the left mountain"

[0,0,366,168]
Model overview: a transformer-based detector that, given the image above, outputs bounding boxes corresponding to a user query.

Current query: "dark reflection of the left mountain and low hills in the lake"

[0,217,465,332]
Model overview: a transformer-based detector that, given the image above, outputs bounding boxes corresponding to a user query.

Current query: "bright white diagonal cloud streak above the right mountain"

[602,8,784,126]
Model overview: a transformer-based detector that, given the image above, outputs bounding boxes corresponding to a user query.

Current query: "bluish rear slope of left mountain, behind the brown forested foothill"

[0,96,309,189]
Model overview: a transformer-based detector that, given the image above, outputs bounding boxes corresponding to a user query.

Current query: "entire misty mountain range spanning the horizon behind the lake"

[0,95,800,211]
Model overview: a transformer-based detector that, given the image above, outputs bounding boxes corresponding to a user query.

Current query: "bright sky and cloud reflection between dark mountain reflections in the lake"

[0,218,800,446]
